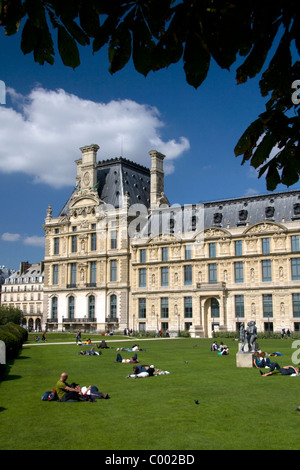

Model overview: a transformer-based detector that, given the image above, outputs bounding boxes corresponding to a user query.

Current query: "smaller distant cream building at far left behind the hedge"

[1,261,44,331]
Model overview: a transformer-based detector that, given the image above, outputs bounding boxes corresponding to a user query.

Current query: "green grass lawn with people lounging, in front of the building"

[0,335,300,451]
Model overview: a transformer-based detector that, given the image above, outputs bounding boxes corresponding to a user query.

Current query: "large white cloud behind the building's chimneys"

[0,88,190,188]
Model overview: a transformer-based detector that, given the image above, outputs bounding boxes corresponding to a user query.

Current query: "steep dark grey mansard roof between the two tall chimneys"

[59,157,150,217]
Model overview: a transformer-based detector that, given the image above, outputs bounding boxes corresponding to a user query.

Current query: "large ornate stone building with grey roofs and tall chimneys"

[44,145,300,336]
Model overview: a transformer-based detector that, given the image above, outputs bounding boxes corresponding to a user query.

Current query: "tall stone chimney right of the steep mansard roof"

[149,150,166,209]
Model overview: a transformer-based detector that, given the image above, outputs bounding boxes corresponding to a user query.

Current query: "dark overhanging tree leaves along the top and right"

[0,0,300,190]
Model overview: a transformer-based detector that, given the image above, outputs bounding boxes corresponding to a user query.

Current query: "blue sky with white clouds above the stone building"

[0,28,299,269]
